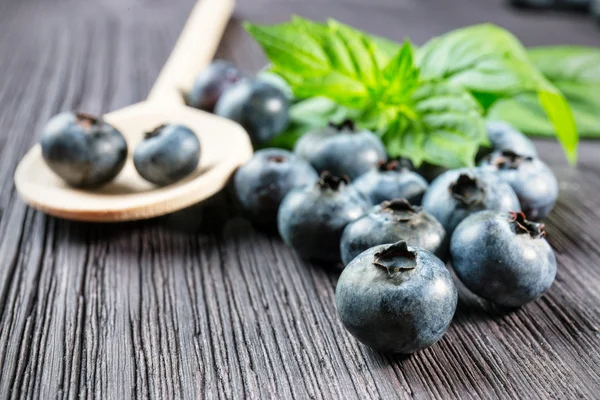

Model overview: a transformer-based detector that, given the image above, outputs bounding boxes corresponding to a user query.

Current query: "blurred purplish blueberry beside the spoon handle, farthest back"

[186,60,245,112]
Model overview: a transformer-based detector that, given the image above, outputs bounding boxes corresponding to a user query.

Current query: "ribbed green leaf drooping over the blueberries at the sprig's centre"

[382,82,486,168]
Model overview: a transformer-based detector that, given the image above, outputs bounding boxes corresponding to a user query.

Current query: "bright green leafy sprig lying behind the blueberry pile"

[246,17,577,168]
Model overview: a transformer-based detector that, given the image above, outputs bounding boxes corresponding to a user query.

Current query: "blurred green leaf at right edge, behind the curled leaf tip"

[489,46,600,138]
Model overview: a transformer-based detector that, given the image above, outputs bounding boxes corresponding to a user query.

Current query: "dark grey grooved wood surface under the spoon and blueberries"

[0,0,600,399]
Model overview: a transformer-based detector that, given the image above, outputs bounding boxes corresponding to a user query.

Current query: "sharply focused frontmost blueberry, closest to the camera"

[335,242,458,353]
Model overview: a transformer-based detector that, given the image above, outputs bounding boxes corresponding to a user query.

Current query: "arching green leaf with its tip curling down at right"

[419,24,578,162]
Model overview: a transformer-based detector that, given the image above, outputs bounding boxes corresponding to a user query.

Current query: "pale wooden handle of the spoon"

[148,0,235,105]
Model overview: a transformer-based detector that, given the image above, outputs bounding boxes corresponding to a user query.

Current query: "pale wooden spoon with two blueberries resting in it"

[15,0,252,222]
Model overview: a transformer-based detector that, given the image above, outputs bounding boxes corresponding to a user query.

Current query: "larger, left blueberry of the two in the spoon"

[40,112,127,188]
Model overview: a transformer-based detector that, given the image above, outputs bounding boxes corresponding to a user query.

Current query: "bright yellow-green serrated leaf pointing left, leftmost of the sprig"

[245,17,408,108]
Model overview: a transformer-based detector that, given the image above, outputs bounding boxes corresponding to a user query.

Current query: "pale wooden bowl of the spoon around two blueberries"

[15,102,252,222]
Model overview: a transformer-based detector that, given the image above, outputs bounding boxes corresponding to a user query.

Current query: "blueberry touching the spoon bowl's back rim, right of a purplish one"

[215,80,290,144]
